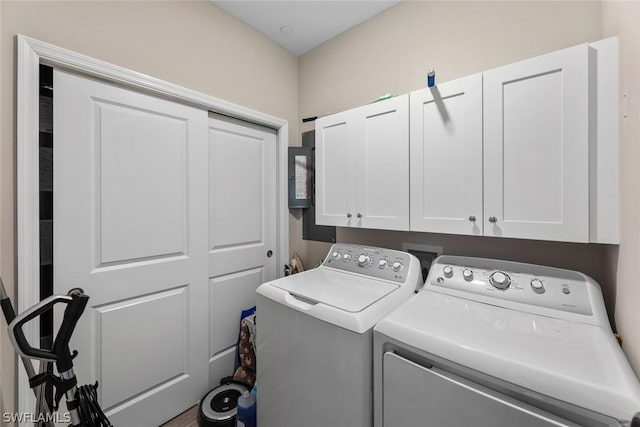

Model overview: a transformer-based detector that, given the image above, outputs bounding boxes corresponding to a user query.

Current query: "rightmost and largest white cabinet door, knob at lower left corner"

[484,45,589,242]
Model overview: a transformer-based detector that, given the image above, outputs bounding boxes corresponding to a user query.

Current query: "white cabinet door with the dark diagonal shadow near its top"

[410,74,483,235]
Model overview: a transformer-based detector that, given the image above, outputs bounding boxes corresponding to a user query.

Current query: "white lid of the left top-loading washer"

[271,268,400,313]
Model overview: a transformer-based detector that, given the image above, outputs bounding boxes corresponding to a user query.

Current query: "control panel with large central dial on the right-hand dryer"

[425,256,601,316]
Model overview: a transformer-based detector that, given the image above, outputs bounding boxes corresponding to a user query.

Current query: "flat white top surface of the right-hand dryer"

[374,290,640,420]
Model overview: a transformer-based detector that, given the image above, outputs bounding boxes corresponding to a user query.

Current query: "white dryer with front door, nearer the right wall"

[374,256,640,427]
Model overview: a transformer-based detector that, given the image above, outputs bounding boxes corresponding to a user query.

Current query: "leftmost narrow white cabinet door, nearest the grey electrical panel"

[316,110,356,227]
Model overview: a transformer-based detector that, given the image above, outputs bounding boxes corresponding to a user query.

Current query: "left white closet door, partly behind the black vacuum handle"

[54,70,209,426]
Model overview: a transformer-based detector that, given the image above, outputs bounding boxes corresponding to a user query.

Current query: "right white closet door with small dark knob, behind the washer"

[207,116,277,388]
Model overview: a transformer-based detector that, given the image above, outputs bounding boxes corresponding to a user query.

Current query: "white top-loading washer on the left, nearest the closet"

[256,244,422,427]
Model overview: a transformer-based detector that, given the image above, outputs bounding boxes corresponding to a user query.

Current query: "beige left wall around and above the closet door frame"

[0,0,298,422]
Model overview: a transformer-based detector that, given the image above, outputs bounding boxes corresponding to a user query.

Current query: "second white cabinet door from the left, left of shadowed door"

[355,94,409,230]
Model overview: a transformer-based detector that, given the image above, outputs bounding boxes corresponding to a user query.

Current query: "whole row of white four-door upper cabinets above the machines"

[316,37,619,244]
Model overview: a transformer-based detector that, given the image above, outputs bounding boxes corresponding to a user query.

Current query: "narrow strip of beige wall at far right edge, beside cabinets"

[602,1,640,374]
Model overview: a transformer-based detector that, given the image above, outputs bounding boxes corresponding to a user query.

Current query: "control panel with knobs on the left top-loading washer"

[322,243,412,283]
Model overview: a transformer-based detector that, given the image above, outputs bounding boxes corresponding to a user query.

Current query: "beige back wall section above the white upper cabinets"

[300,1,600,117]
